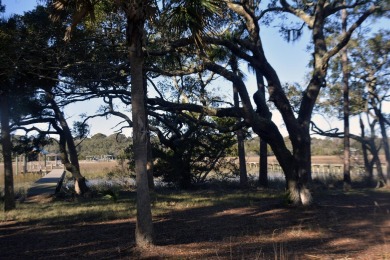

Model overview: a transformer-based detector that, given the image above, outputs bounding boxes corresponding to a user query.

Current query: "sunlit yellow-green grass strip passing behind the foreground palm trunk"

[0,190,280,223]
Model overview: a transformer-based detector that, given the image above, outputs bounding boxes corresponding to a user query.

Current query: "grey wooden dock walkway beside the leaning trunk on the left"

[27,169,65,197]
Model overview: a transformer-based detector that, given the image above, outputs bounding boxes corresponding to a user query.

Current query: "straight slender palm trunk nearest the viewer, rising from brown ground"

[125,0,154,247]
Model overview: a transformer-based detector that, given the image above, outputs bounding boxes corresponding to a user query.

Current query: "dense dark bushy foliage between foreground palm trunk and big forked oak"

[153,115,236,188]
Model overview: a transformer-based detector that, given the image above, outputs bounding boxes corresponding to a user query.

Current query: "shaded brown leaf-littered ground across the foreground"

[0,190,390,260]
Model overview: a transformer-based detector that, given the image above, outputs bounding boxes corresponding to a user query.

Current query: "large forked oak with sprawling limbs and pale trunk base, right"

[149,1,381,205]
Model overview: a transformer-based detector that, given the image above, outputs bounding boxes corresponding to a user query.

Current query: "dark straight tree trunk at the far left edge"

[0,92,15,211]
